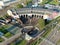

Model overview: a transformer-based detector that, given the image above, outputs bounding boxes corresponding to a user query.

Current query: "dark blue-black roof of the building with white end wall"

[22,28,40,37]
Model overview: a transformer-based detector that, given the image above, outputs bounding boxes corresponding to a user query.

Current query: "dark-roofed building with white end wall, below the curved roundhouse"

[21,27,40,41]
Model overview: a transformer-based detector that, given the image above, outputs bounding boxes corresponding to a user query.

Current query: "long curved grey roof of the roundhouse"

[17,8,57,14]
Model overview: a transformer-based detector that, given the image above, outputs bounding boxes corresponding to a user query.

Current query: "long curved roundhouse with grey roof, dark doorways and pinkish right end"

[7,8,59,20]
